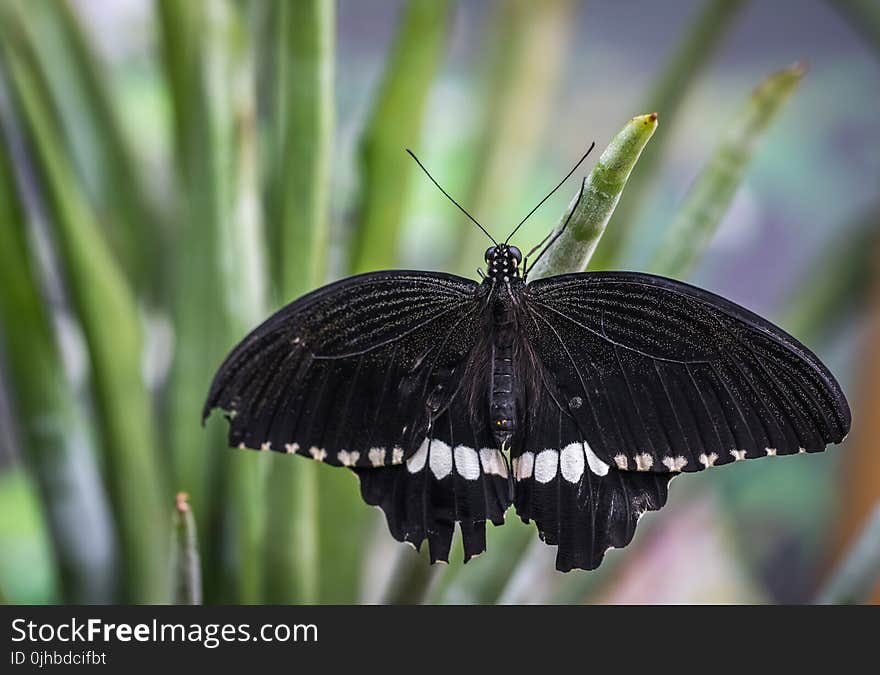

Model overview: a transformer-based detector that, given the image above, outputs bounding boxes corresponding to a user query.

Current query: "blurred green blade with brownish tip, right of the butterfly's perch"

[650,65,806,276]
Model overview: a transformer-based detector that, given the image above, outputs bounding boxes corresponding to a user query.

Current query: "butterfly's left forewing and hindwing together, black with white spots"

[204,271,510,560]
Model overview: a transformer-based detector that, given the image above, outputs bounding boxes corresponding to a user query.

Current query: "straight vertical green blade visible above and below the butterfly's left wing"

[265,0,336,603]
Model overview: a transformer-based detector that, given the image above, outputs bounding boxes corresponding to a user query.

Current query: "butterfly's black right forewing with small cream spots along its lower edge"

[524,272,850,473]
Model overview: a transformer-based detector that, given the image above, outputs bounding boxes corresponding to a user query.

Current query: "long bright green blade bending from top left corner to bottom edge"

[2,32,168,602]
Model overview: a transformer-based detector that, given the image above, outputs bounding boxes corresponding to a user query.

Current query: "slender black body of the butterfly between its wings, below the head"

[489,292,518,447]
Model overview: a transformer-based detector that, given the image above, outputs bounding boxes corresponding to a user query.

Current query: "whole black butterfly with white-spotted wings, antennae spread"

[203,146,851,572]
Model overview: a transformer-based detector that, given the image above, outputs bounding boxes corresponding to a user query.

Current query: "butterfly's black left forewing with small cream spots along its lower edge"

[204,271,483,467]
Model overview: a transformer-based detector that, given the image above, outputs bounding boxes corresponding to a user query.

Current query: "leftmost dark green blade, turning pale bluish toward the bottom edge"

[0,112,116,603]
